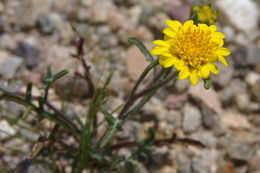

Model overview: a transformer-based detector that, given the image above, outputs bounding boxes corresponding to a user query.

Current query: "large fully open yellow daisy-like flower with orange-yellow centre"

[151,20,230,85]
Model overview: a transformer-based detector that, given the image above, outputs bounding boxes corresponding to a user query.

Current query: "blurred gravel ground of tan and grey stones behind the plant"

[0,0,260,173]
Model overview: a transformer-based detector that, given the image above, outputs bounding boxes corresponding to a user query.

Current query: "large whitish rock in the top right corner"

[215,0,258,32]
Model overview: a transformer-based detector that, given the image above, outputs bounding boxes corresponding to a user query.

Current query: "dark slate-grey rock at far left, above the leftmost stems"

[15,41,40,68]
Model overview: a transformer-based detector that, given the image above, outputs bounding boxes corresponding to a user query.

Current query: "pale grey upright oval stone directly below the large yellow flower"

[182,104,201,133]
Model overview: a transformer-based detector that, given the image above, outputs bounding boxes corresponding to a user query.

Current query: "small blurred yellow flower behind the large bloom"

[192,5,218,25]
